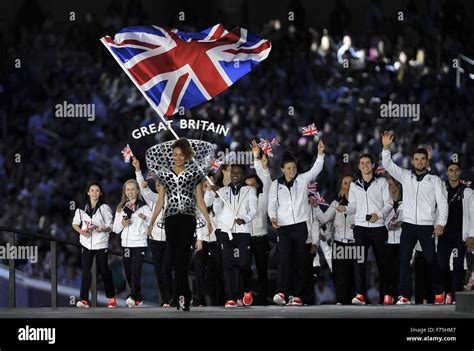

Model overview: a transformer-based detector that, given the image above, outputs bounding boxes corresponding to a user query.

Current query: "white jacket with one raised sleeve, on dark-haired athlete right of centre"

[268,155,324,226]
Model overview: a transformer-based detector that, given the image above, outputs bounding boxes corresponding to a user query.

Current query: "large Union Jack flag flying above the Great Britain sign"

[101,24,271,117]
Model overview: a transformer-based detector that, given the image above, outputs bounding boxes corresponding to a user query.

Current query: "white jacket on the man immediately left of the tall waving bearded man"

[345,177,393,228]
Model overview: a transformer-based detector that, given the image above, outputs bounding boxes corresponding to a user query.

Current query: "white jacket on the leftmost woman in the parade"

[72,204,113,250]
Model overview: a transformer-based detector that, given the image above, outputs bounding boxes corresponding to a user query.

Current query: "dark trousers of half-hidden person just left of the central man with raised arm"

[244,235,270,305]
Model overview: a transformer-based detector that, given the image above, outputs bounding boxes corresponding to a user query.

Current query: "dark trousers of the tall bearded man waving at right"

[398,222,443,298]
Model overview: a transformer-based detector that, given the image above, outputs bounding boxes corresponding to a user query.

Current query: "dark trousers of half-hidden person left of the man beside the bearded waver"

[332,240,356,305]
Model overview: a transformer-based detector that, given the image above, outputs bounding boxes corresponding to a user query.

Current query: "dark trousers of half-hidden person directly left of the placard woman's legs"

[148,239,173,303]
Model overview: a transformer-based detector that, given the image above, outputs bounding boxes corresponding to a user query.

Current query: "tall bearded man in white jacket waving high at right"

[382,132,448,304]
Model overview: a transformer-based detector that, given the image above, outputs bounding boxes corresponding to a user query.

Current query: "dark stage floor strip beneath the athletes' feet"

[0,305,474,318]
